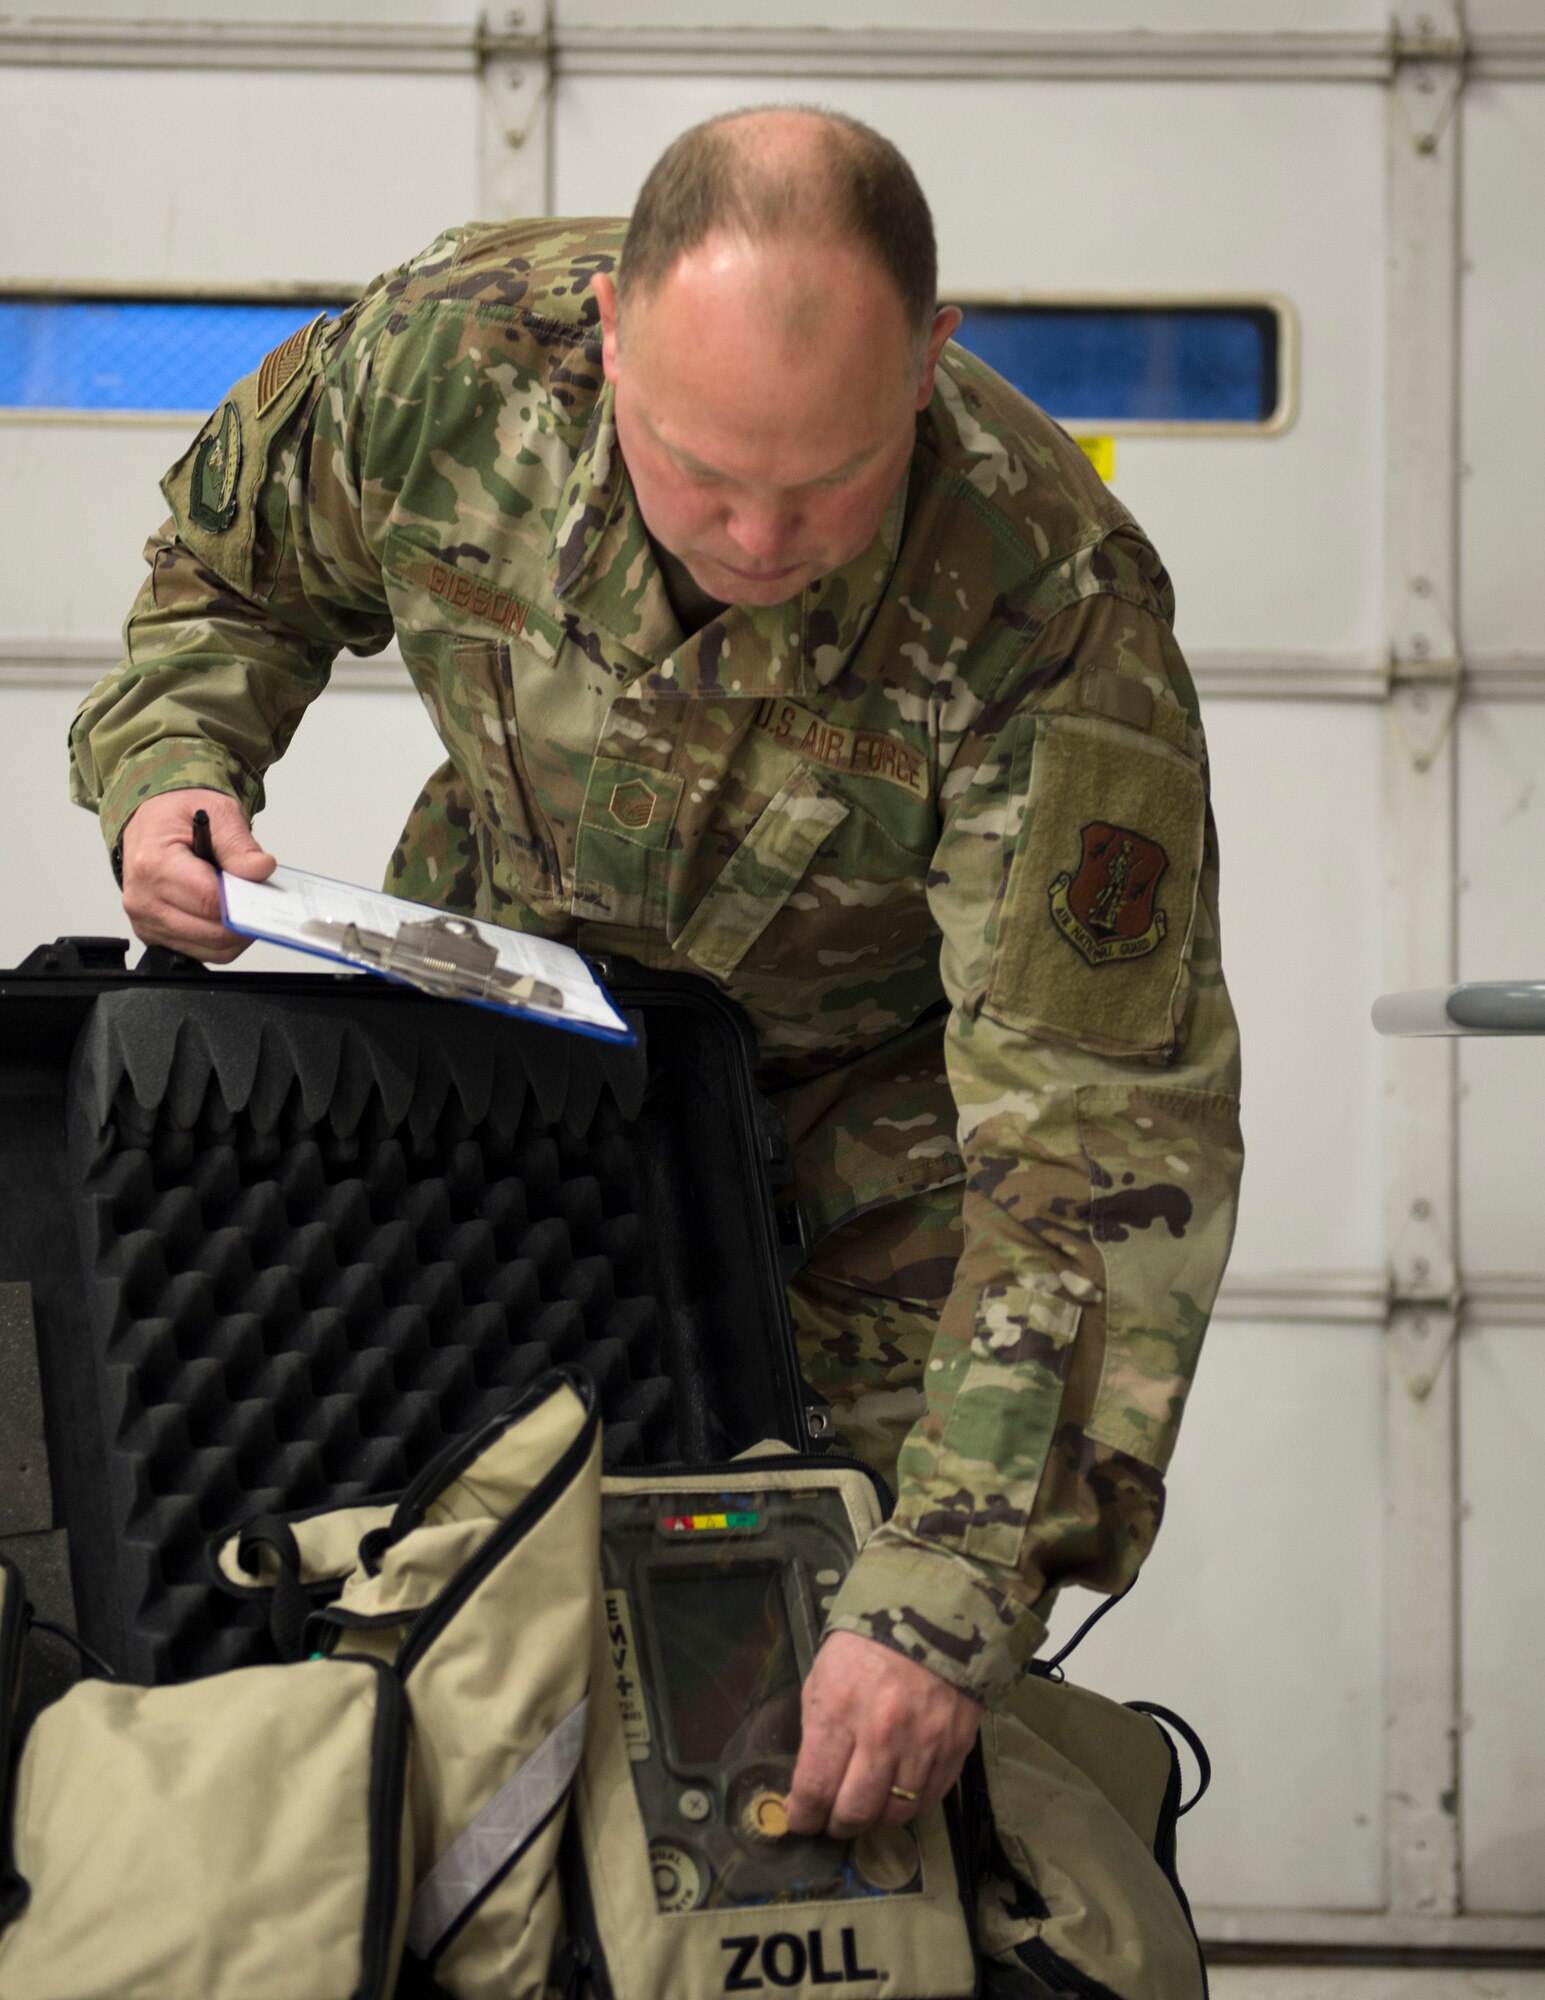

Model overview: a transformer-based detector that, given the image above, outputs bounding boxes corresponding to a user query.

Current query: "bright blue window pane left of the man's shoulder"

[0,298,338,412]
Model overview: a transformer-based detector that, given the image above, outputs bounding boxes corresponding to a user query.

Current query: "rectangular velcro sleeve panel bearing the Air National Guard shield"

[983,716,1207,1056]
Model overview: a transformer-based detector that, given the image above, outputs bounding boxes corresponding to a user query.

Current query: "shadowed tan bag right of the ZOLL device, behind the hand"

[967,1670,1207,2000]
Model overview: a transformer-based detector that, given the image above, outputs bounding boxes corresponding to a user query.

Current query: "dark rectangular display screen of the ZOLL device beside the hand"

[648,1564,799,1766]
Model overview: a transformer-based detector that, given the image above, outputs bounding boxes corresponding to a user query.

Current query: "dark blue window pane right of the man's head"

[955,306,1281,424]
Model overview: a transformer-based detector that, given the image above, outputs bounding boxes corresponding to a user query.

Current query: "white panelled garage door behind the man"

[0,0,1545,1950]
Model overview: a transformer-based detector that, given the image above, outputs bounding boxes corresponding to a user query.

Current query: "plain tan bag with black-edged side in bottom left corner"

[0,1558,410,2000]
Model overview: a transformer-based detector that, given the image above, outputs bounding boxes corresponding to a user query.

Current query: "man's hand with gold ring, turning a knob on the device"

[787,1632,983,1840]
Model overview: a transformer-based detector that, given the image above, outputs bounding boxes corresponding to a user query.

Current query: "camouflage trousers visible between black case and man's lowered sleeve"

[789,1182,961,1492]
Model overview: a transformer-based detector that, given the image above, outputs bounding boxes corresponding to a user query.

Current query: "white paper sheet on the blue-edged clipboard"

[220,866,636,1042]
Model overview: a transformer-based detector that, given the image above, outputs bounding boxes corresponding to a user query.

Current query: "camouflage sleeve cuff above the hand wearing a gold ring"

[827,1522,1047,1702]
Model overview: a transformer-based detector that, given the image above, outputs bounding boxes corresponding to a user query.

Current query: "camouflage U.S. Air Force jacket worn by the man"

[72,220,1239,1694]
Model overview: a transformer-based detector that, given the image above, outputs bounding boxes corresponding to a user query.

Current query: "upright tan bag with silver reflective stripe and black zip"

[216,1374,600,2000]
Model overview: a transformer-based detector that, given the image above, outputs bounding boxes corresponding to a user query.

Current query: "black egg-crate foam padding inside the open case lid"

[55,982,792,1682]
